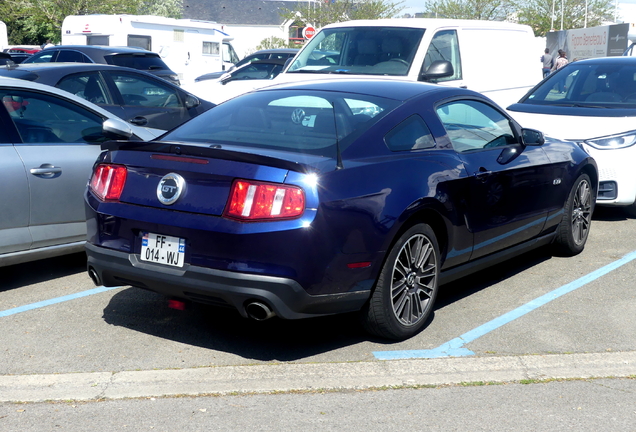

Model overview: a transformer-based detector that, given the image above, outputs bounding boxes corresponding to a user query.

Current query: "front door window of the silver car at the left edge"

[0,89,106,144]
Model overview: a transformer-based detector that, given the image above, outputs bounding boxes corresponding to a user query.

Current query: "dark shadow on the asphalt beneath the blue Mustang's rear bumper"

[103,288,370,361]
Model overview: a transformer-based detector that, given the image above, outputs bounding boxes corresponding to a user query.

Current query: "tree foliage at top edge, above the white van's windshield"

[281,0,404,28]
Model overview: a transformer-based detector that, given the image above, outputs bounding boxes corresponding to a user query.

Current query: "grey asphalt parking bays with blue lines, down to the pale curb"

[0,208,636,401]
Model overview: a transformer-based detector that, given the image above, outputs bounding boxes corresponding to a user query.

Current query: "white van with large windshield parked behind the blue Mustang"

[275,18,543,107]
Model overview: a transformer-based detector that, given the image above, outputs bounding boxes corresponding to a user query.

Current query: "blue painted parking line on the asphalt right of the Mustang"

[373,251,636,360]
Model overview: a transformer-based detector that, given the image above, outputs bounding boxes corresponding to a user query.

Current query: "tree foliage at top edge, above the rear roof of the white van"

[424,0,515,21]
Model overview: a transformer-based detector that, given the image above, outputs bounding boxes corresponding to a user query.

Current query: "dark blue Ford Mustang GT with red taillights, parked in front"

[86,80,598,339]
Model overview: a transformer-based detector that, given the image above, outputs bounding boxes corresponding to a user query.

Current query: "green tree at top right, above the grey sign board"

[517,0,614,36]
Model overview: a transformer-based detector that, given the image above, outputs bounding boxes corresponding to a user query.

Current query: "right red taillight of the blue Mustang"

[225,180,305,221]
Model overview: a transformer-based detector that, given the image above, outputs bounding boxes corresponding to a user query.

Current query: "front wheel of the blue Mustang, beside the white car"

[555,174,596,256]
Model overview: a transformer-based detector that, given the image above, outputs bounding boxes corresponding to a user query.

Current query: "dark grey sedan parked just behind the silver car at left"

[0,62,214,130]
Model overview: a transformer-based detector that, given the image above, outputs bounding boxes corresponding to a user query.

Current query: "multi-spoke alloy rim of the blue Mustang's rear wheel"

[391,234,437,326]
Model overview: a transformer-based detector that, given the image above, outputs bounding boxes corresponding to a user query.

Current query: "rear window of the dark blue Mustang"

[161,90,400,158]
